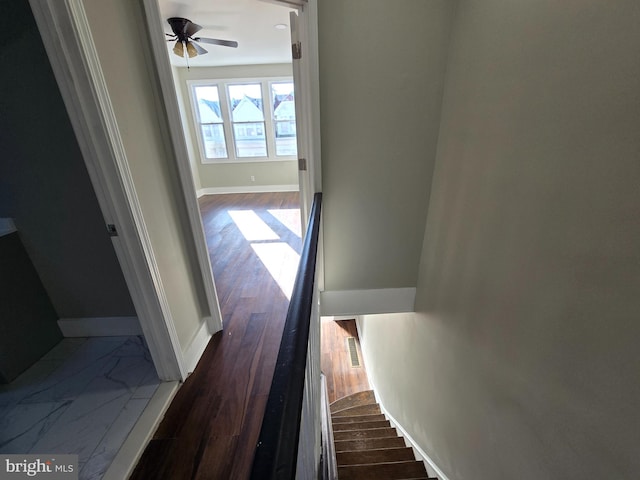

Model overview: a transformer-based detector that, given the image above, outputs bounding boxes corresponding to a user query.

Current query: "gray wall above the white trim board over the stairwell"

[318,0,453,291]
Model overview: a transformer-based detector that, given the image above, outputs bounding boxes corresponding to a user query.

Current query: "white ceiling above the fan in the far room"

[158,0,291,67]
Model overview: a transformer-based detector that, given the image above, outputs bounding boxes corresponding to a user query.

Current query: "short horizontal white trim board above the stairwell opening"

[320,287,416,316]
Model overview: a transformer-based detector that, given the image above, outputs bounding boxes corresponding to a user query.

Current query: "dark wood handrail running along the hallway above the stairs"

[250,193,322,480]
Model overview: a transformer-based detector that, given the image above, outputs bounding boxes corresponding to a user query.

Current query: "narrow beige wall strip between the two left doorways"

[84,0,211,352]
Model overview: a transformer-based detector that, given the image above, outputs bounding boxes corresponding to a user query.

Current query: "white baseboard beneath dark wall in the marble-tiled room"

[58,317,142,337]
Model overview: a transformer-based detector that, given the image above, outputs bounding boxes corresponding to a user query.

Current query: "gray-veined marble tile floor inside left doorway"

[0,336,160,480]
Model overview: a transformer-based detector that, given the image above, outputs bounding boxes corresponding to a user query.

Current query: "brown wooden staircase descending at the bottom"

[330,390,437,480]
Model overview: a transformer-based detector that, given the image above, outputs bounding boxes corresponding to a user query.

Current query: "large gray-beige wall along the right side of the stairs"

[361,0,640,480]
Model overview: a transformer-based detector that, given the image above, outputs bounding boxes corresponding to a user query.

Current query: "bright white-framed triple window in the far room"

[189,78,297,163]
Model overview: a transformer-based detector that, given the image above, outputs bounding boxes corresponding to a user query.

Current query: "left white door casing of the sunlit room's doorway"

[144,0,222,333]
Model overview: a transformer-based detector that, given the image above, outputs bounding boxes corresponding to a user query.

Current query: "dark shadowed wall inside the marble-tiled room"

[0,0,135,317]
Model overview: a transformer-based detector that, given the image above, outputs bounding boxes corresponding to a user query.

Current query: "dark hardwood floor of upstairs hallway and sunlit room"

[131,193,301,480]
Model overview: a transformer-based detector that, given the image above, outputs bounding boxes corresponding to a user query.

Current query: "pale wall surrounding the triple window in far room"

[174,64,298,191]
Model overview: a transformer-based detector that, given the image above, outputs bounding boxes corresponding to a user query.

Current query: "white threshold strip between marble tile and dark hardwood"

[102,381,180,480]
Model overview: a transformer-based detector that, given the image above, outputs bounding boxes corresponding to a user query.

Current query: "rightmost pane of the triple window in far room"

[271,82,297,155]
